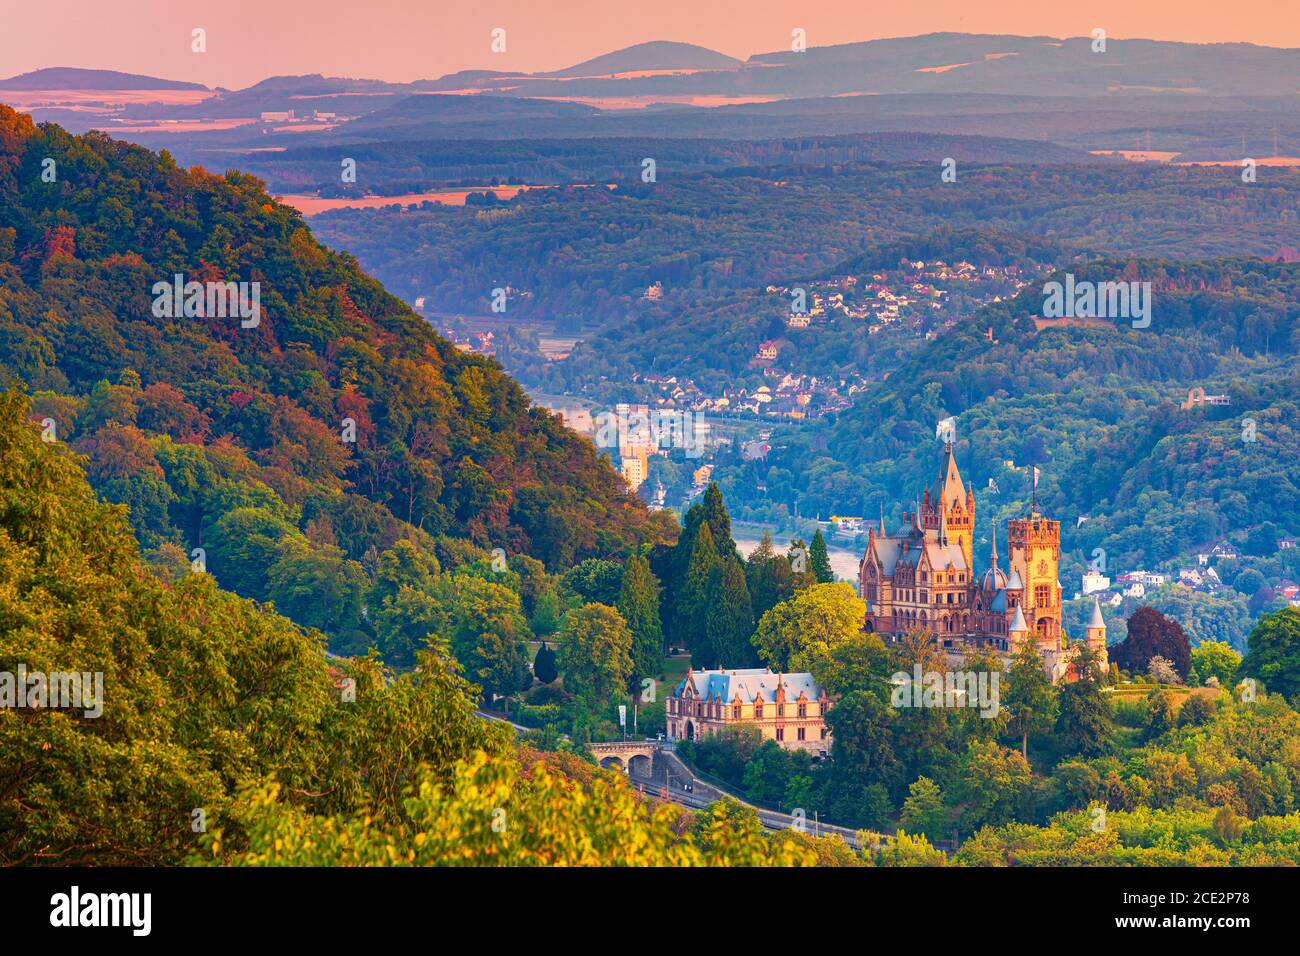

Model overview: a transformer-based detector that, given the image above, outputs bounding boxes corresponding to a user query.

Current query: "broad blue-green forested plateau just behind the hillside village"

[312,157,1300,321]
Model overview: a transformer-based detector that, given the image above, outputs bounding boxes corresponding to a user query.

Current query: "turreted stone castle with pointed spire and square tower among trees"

[858,442,1109,682]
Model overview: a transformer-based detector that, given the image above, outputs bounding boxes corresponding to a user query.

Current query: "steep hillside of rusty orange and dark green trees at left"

[0,108,675,650]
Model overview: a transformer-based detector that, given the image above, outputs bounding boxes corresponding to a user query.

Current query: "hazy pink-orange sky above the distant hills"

[0,0,1300,87]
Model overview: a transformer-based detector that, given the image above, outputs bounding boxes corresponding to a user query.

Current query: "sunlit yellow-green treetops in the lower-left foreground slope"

[0,392,816,866]
